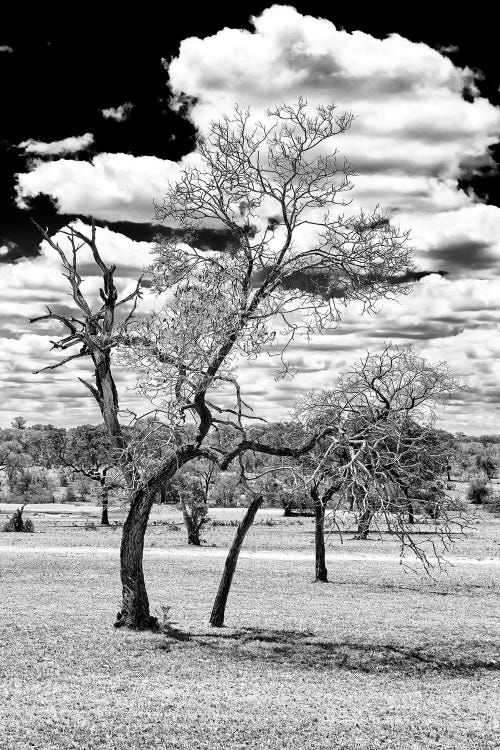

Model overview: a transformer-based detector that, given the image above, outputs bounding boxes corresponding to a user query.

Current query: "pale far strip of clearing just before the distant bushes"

[0,505,500,559]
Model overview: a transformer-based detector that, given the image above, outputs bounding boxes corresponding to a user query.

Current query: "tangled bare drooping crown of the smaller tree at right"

[297,345,467,570]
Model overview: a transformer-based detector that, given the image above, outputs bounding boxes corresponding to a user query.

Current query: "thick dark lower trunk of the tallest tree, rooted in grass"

[115,490,158,630]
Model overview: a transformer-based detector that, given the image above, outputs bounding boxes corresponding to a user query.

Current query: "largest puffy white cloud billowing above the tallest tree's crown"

[169,5,500,216]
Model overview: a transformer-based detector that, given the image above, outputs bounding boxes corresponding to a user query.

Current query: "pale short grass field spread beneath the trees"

[0,506,500,750]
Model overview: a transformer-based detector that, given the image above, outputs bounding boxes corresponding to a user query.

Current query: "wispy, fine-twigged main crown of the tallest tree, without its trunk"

[123,101,410,624]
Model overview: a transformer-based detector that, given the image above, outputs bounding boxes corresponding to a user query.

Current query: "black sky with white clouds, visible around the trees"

[0,2,500,434]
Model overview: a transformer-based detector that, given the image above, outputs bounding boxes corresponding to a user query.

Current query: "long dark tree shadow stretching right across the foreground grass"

[157,628,500,677]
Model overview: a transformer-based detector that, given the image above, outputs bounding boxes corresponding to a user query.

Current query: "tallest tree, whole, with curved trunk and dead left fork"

[33,100,411,628]
